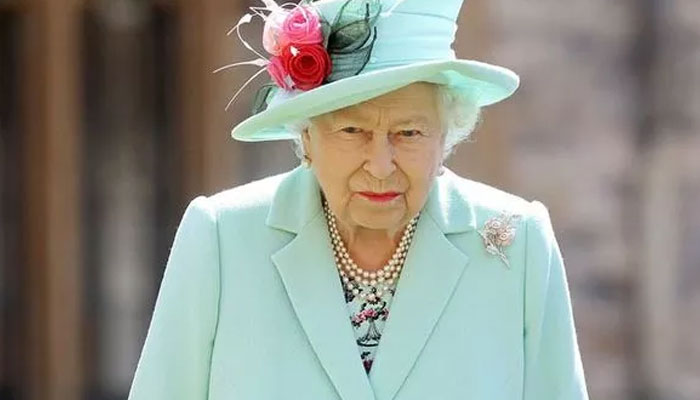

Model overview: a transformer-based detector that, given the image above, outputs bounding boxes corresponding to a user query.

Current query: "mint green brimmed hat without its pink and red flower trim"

[231,0,520,142]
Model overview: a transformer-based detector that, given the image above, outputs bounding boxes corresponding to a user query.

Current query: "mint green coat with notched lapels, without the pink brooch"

[129,167,588,400]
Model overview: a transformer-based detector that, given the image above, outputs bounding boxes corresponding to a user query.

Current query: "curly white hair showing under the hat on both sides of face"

[285,84,482,160]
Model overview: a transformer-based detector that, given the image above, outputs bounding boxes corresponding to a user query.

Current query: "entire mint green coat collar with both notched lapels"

[267,167,475,400]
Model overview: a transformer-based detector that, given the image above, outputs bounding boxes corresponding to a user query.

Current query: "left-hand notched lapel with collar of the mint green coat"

[268,169,374,400]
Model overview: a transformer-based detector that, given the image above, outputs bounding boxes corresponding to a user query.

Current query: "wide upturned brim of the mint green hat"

[231,59,520,142]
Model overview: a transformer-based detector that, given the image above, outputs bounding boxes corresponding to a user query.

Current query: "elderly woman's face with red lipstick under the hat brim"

[302,82,444,232]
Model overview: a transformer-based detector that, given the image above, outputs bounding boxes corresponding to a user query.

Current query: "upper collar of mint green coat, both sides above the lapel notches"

[266,166,476,234]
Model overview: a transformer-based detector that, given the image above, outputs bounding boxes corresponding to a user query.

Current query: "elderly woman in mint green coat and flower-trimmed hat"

[129,0,588,400]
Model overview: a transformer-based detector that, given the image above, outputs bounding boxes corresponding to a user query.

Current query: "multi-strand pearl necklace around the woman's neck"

[323,199,420,300]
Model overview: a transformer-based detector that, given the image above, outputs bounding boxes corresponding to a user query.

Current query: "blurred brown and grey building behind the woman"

[0,0,700,400]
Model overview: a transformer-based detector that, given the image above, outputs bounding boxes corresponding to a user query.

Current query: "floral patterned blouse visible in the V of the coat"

[341,275,400,374]
